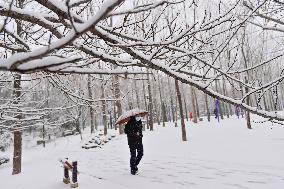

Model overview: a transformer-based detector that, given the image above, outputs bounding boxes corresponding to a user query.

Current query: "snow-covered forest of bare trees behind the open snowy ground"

[0,0,284,182]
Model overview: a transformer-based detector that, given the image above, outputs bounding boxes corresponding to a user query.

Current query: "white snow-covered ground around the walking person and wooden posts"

[0,115,284,189]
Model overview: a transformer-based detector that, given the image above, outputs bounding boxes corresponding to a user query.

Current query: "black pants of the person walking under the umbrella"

[129,142,143,168]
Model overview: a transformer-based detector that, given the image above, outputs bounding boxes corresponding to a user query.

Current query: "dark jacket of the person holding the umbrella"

[124,117,143,145]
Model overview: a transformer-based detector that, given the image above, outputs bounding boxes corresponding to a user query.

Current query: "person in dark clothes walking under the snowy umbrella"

[124,116,143,175]
